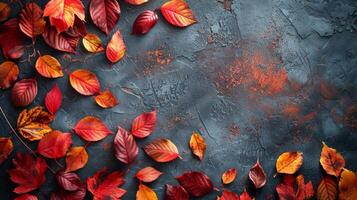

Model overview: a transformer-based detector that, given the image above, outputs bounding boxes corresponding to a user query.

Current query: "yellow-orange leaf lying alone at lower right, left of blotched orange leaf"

[275,152,303,174]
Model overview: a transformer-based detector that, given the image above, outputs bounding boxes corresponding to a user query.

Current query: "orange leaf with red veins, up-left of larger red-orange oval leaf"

[35,55,63,78]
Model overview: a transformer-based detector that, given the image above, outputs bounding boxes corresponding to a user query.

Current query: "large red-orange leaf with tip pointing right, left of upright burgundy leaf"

[74,116,112,141]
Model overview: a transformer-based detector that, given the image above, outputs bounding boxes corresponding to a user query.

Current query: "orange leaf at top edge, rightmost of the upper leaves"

[161,0,197,27]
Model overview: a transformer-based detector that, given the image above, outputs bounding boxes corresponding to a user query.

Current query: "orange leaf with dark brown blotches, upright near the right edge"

[320,142,345,177]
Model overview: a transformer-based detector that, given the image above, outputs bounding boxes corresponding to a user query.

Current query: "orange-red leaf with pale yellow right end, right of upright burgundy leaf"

[144,139,180,162]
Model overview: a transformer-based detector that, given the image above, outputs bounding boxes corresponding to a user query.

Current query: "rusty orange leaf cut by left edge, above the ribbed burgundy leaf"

[0,61,20,89]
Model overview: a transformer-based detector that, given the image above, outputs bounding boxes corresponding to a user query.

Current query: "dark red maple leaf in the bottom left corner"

[8,153,47,194]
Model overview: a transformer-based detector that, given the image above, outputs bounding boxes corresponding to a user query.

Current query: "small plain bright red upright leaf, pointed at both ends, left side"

[45,84,62,115]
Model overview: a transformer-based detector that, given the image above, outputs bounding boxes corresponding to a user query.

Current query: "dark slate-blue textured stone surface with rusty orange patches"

[0,0,357,200]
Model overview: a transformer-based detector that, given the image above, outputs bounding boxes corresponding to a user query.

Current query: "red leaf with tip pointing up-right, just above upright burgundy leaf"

[131,110,156,138]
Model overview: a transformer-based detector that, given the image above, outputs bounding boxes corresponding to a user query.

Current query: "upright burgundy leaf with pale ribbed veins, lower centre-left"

[114,127,139,164]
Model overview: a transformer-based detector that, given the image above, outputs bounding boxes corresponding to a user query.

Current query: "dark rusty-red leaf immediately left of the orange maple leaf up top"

[19,2,46,38]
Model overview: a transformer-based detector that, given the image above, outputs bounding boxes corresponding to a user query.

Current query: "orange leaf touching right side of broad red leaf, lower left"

[66,146,88,172]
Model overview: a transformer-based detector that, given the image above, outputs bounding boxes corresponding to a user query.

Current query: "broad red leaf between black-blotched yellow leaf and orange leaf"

[37,131,72,159]
